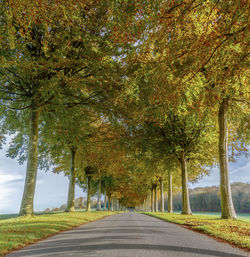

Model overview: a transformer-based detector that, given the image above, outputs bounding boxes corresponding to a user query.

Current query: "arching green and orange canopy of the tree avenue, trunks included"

[0,0,249,218]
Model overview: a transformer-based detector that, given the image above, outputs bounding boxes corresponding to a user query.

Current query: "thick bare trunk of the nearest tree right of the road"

[218,98,237,219]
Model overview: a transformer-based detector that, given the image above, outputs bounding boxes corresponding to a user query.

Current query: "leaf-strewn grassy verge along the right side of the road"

[144,212,250,250]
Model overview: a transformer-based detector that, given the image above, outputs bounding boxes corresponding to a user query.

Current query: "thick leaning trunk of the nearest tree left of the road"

[19,109,40,216]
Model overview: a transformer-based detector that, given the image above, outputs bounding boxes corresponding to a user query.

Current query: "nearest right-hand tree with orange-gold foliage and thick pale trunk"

[145,0,249,218]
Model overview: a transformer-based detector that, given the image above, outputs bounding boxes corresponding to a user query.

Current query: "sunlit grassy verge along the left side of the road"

[0,211,117,256]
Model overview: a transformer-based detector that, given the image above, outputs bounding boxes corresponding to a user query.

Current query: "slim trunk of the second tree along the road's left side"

[65,147,76,212]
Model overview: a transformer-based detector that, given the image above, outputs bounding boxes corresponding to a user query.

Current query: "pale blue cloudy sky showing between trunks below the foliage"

[0,137,250,214]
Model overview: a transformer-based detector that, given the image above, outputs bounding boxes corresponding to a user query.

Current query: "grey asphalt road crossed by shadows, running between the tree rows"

[7,212,250,257]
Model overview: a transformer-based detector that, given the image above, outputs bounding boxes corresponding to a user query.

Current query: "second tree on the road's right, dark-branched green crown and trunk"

[141,103,217,214]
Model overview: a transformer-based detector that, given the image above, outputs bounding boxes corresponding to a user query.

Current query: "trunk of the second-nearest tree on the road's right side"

[180,153,192,214]
